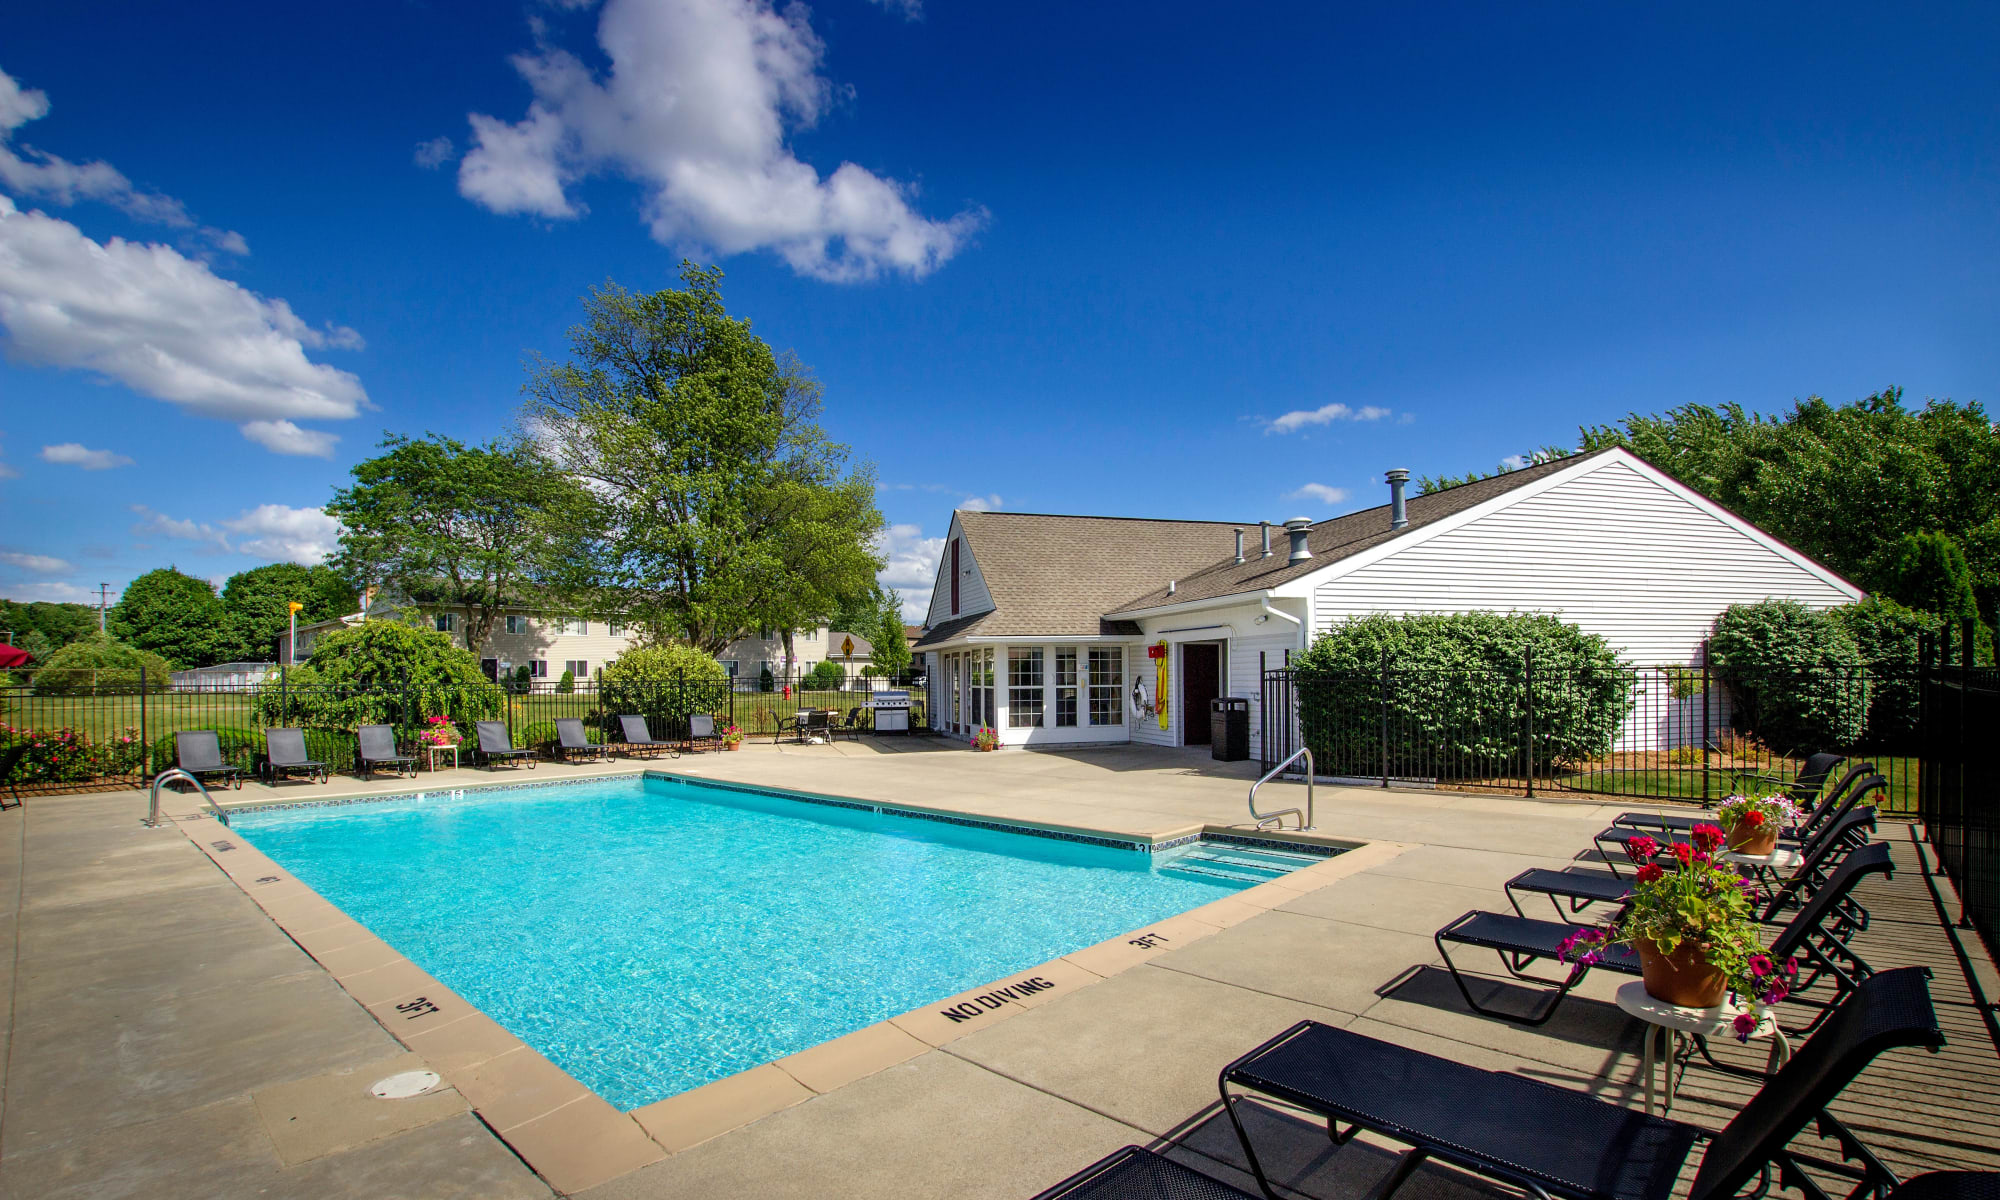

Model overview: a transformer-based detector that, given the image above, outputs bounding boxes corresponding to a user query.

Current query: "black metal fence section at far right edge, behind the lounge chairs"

[1918,640,2000,954]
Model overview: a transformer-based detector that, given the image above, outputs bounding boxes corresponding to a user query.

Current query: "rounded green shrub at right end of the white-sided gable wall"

[1708,600,1870,754]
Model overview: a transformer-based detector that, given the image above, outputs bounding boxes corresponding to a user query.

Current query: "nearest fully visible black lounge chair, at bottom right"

[1216,966,1944,1200]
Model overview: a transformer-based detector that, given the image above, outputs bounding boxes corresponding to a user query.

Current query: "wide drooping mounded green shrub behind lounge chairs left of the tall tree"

[256,620,500,732]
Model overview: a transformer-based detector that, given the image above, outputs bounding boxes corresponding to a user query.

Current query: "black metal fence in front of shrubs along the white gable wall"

[1260,656,1920,812]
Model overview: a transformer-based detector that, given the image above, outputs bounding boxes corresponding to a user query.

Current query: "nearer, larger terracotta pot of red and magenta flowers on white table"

[1562,824,1798,1040]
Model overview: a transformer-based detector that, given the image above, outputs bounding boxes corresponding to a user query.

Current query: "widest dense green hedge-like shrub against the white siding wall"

[1294,612,1634,778]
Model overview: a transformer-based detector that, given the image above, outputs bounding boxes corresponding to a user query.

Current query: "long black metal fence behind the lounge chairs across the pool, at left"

[0,670,924,790]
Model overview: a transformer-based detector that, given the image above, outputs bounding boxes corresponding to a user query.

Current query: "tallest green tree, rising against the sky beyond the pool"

[524,262,882,654]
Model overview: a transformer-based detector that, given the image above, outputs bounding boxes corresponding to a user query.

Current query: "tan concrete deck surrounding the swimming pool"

[0,742,2000,1200]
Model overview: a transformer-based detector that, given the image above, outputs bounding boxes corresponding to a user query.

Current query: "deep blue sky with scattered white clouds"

[0,0,2000,620]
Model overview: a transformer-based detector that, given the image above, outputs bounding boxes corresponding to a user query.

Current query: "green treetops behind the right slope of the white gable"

[1582,388,2000,624]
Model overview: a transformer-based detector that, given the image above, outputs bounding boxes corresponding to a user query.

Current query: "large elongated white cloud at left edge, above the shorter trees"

[0,196,368,456]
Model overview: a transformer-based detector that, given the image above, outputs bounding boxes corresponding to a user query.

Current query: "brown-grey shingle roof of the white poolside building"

[916,450,1602,648]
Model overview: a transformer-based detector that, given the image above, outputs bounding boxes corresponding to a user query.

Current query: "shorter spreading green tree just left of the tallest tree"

[326,434,586,650]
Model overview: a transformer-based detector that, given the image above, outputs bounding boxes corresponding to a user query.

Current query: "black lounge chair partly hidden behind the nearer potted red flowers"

[1432,842,1894,1030]
